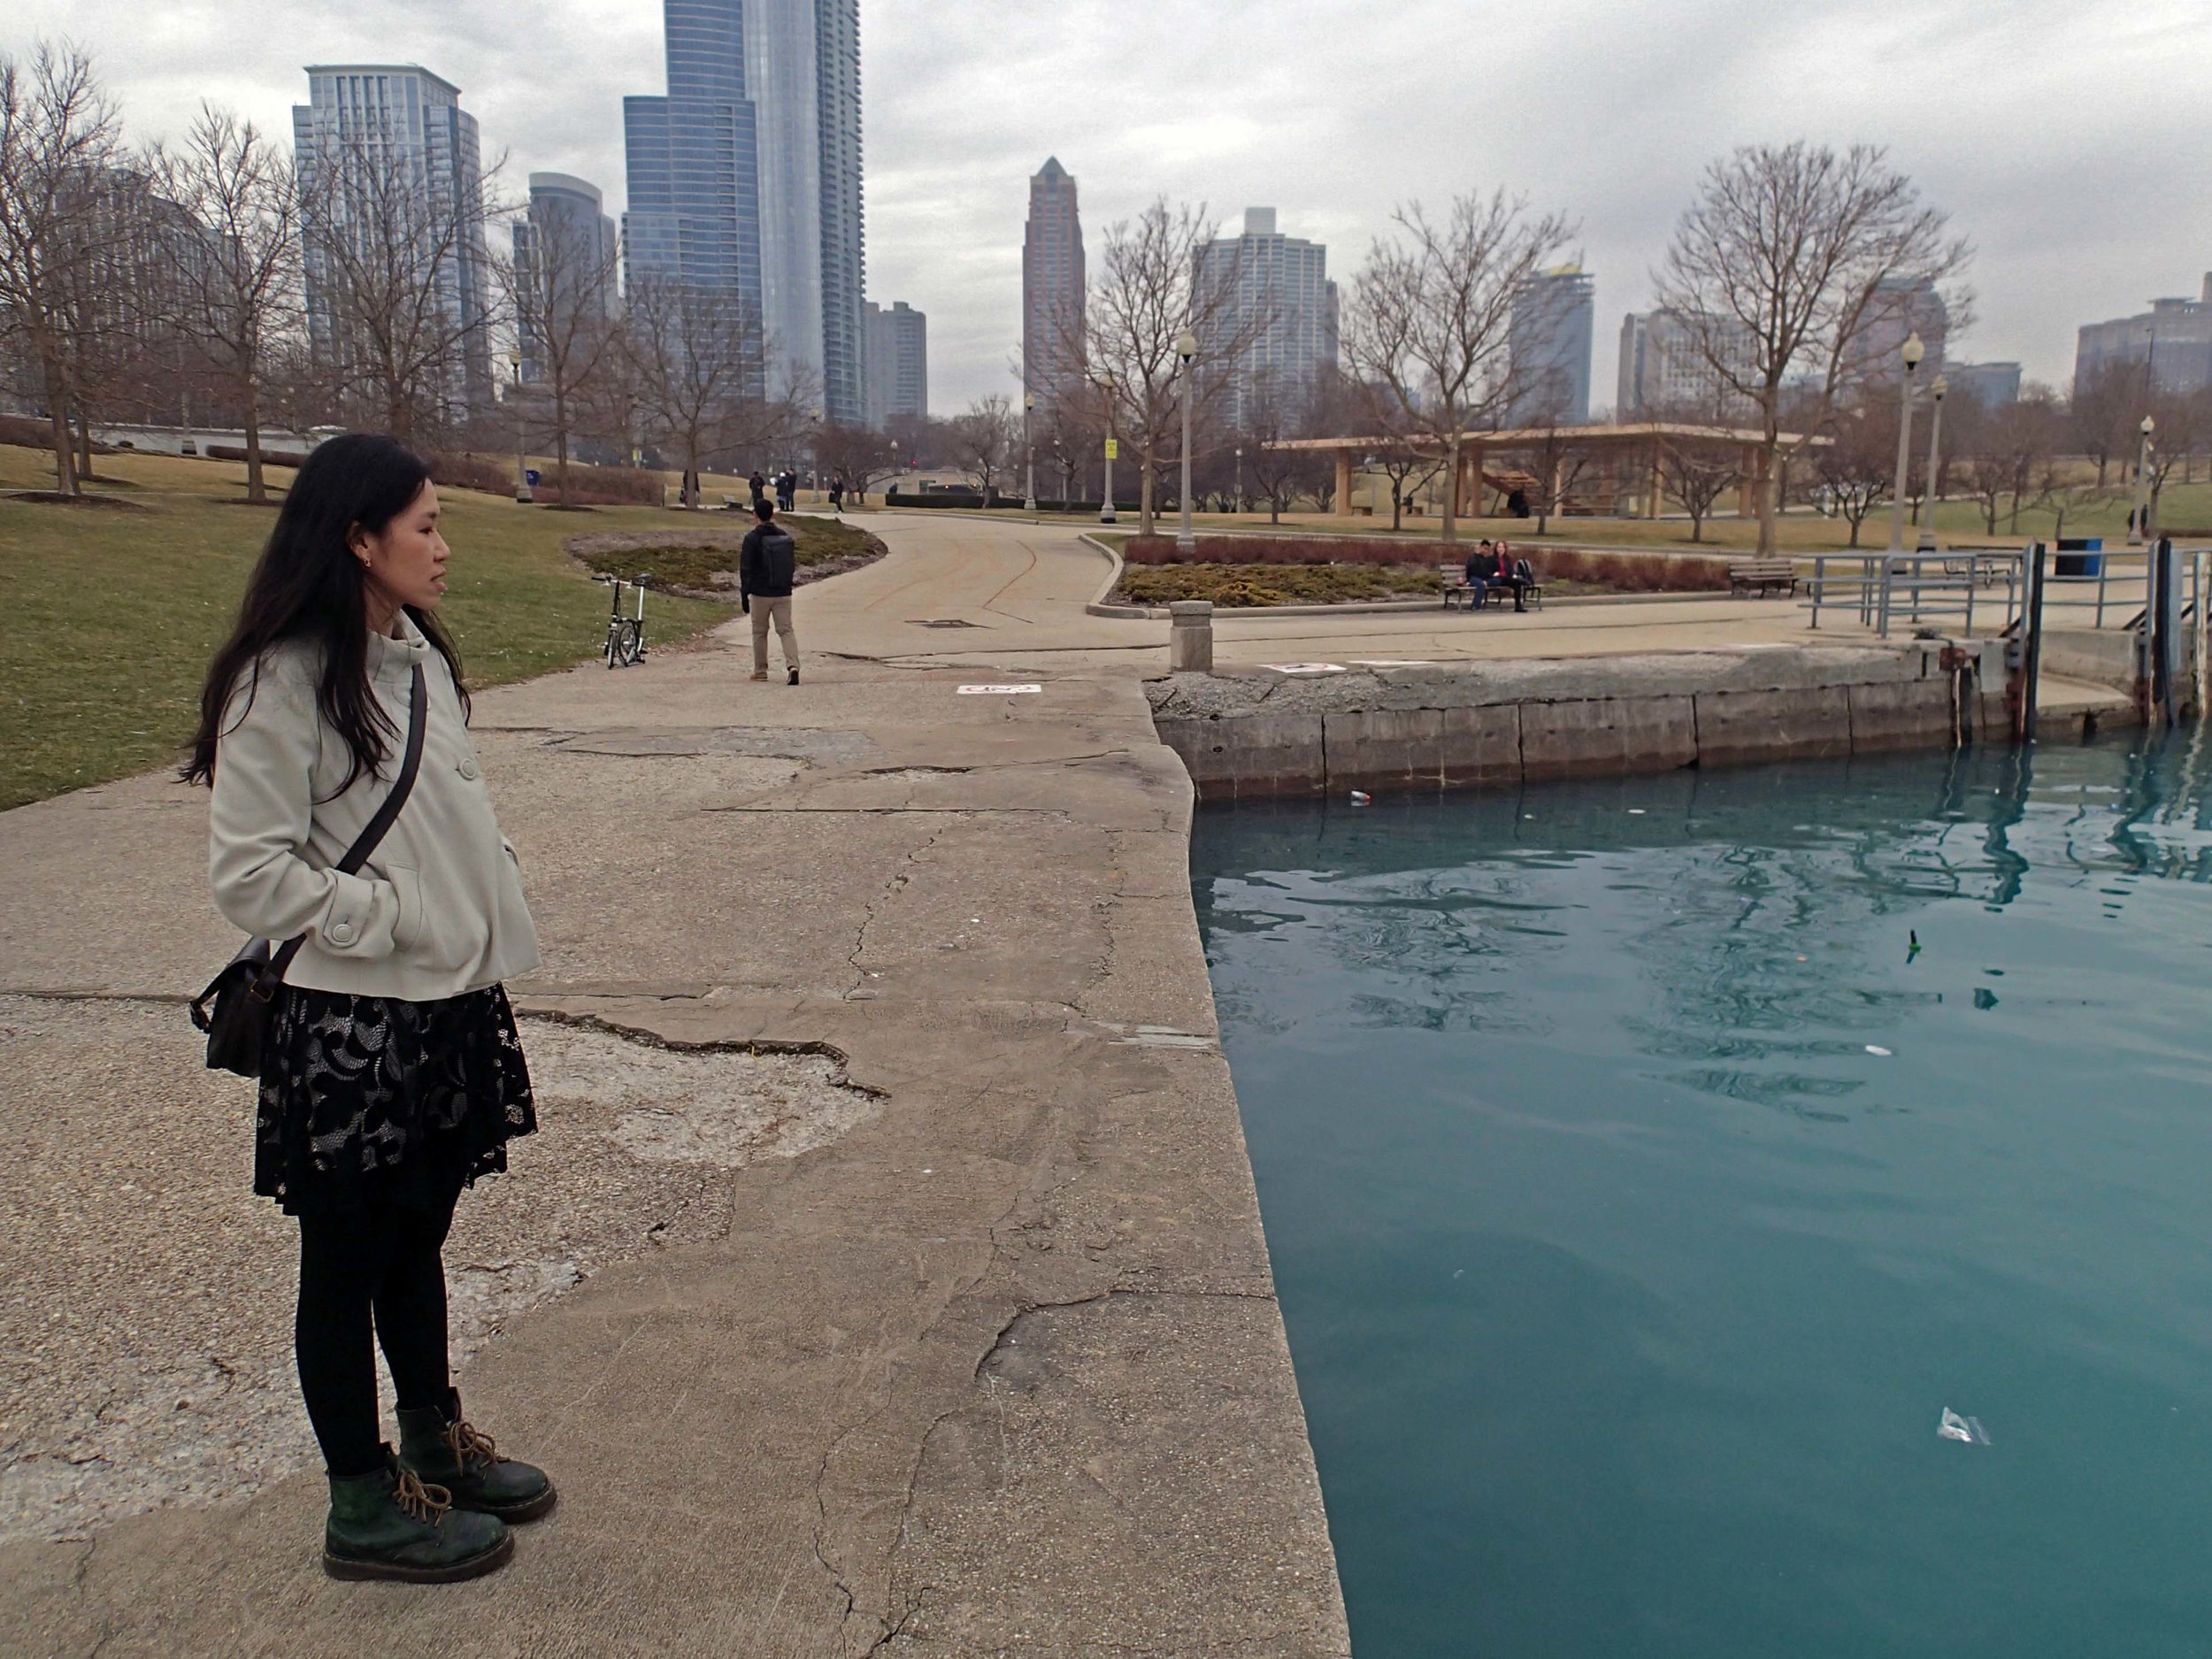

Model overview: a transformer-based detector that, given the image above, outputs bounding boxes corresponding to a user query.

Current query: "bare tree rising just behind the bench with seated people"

[1343,190,1573,542]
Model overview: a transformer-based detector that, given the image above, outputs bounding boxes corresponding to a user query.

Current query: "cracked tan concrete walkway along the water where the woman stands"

[0,520,1348,1659]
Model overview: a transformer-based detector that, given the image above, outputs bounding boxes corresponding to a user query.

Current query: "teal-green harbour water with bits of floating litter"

[1193,737,2212,1659]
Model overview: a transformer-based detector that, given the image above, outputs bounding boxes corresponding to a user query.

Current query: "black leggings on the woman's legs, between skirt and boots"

[292,1202,454,1478]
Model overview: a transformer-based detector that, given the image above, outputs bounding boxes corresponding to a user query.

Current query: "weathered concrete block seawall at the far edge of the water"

[1146,640,2007,801]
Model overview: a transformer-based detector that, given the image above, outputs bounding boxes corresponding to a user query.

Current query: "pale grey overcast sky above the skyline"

[17,0,2212,414]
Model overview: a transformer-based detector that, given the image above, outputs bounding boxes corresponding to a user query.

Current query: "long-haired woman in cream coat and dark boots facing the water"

[184,434,553,1582]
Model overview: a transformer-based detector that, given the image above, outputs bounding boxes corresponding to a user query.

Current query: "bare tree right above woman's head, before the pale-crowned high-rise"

[303,131,498,438]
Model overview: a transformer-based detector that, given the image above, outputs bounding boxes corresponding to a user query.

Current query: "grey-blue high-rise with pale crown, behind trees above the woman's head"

[292,65,491,420]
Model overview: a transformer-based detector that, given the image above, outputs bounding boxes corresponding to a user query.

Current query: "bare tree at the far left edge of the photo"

[0,40,119,495]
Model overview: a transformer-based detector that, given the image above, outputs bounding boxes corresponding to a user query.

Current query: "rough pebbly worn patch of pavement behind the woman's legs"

[0,998,879,1540]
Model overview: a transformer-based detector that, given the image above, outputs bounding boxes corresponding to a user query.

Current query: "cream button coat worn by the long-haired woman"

[208,615,538,1002]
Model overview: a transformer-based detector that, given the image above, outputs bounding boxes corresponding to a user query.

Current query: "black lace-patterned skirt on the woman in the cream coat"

[255,985,538,1215]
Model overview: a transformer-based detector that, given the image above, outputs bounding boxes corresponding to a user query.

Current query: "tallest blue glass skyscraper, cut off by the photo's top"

[622,0,865,423]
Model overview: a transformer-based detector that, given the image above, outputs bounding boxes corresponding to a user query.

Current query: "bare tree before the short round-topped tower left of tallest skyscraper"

[498,197,622,503]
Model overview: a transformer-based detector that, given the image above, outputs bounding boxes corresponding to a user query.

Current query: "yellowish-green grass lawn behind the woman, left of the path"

[0,445,730,810]
